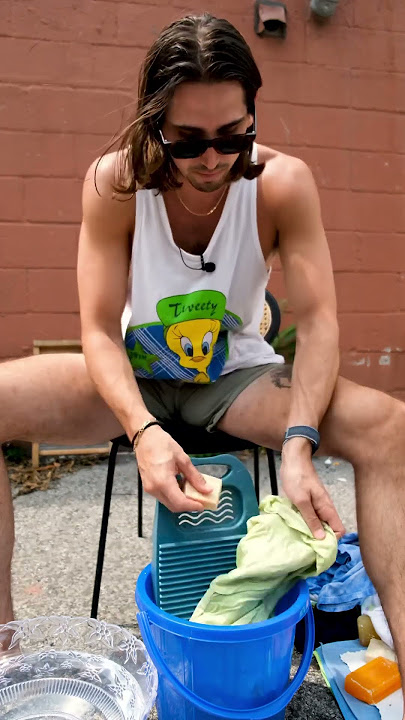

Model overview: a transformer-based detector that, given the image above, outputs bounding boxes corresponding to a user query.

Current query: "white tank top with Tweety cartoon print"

[125,150,284,383]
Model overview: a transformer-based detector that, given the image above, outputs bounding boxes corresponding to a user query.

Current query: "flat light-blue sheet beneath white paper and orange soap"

[316,640,380,720]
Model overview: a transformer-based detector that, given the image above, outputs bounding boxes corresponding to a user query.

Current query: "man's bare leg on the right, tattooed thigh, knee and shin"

[219,368,405,720]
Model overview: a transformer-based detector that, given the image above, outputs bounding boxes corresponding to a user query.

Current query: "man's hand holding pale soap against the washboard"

[135,425,211,513]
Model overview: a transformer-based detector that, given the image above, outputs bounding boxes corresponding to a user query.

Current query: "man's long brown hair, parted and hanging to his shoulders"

[109,13,264,194]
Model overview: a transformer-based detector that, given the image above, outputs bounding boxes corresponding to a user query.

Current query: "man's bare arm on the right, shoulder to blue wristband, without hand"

[278,161,339,434]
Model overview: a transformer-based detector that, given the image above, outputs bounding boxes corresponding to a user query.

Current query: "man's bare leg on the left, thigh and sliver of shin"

[0,354,123,624]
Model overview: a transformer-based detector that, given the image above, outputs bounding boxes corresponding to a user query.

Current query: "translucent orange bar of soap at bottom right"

[345,657,401,705]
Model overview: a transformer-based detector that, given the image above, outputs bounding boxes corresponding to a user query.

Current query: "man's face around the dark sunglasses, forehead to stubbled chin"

[162,82,253,192]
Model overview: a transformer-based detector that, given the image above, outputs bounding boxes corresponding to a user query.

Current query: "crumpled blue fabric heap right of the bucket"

[307,533,376,612]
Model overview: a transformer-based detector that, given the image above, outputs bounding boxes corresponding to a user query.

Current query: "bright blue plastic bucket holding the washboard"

[135,565,314,720]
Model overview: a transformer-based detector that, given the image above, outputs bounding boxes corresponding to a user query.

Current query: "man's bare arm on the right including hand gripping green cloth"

[268,160,344,537]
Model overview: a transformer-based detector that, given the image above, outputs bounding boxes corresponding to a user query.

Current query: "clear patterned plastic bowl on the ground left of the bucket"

[0,616,157,720]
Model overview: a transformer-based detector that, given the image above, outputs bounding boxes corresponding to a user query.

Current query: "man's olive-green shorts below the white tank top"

[137,364,274,431]
